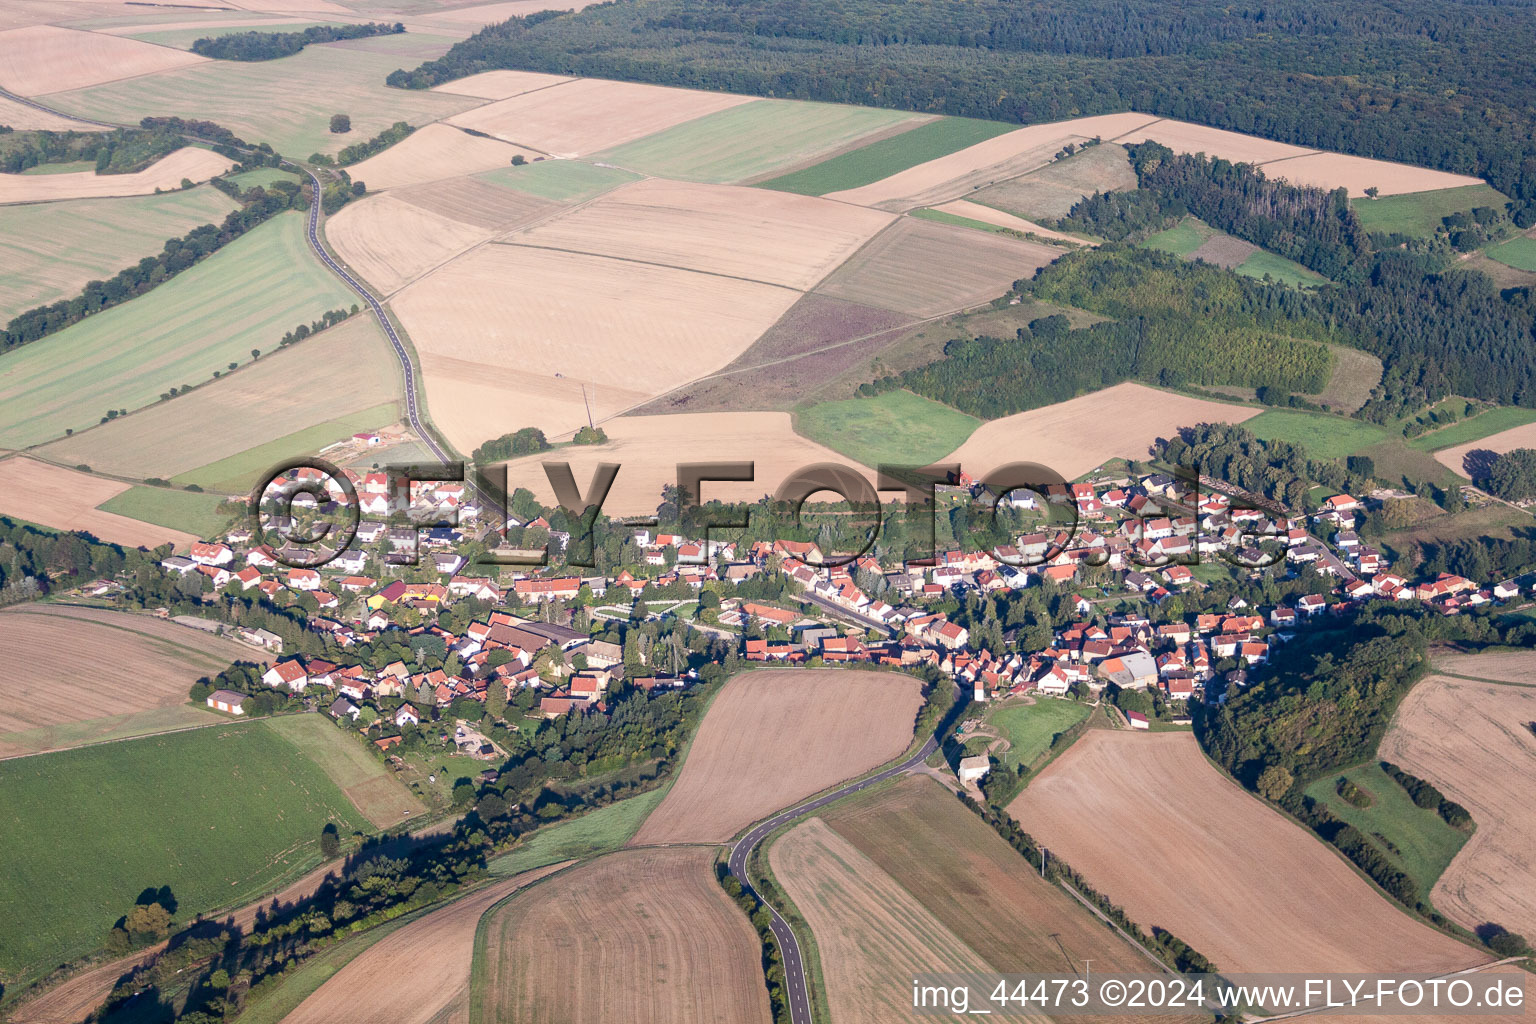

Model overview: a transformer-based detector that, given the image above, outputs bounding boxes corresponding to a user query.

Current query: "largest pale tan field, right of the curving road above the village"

[393,246,799,451]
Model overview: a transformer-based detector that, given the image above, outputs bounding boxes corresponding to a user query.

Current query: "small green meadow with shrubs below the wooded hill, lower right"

[1306,763,1467,898]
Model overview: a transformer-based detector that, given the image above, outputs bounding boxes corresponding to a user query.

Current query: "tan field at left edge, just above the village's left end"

[0,456,197,550]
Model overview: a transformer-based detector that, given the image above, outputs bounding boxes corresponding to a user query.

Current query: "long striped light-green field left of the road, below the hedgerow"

[0,213,356,447]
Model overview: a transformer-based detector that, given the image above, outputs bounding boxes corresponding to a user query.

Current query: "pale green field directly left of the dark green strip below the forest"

[596,100,915,183]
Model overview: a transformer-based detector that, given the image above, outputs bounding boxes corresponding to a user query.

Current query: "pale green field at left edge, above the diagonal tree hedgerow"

[0,184,235,321]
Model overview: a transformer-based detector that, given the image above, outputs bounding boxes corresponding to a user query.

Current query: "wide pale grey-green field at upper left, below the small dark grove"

[49,32,484,160]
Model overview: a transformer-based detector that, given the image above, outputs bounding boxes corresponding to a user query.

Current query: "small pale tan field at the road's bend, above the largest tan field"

[326,193,495,295]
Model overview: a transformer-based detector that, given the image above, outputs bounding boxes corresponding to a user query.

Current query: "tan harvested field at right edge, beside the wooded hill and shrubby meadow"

[1381,672,1536,935]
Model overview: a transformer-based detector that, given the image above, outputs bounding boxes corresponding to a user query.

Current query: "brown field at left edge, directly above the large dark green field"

[0,605,253,757]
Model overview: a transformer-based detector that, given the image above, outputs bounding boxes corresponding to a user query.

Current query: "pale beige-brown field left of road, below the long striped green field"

[40,317,401,494]
